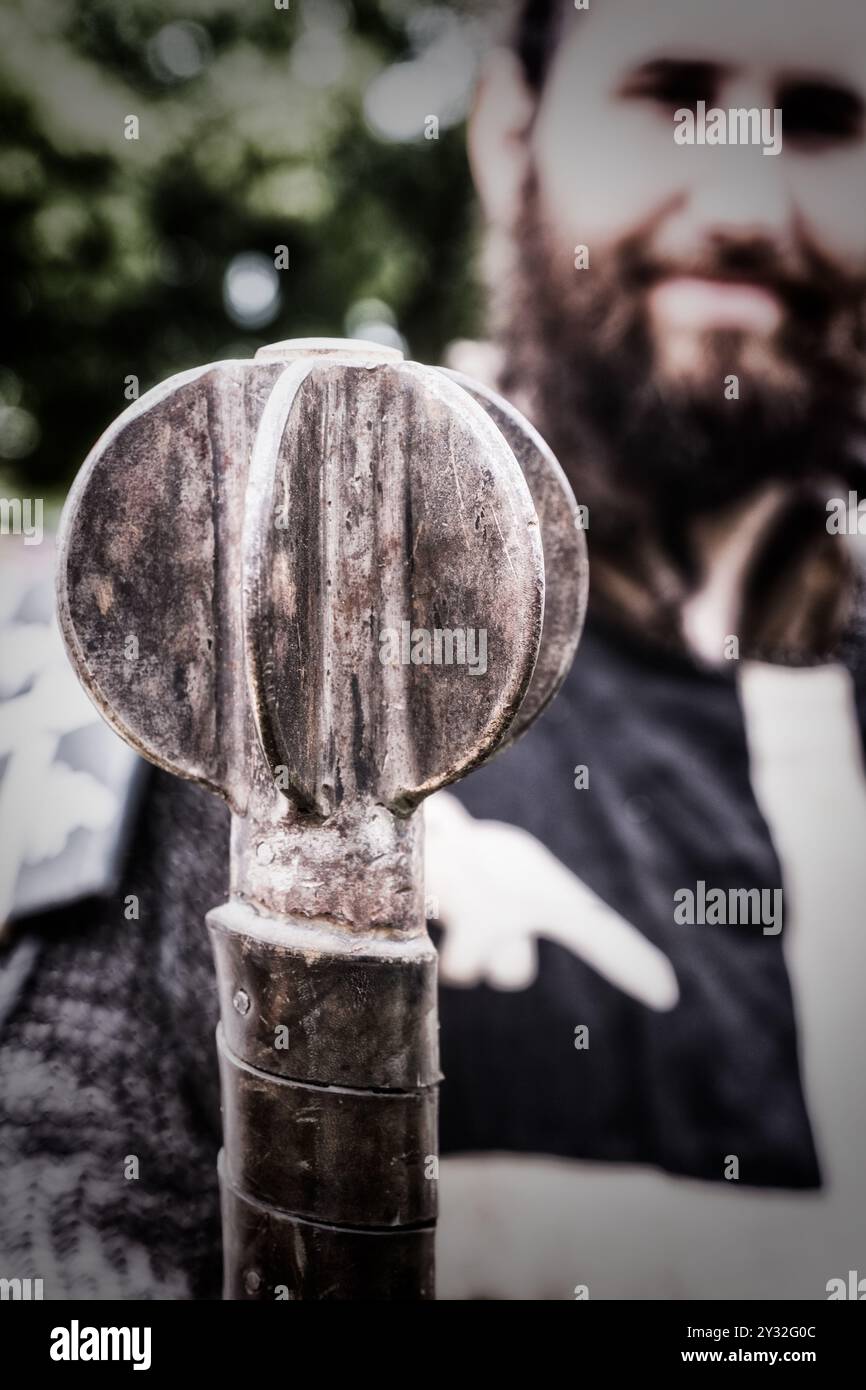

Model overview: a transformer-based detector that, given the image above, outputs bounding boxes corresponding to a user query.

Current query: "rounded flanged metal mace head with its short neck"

[58,339,588,930]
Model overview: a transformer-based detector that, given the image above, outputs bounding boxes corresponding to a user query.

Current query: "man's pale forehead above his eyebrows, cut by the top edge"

[557,0,866,89]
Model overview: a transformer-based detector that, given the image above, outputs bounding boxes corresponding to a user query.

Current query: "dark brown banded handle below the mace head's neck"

[207,901,439,1300]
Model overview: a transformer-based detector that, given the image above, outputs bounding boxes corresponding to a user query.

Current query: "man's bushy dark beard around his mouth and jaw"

[499,177,866,564]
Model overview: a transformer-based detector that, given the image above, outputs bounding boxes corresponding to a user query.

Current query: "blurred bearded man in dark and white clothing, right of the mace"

[428,0,866,1298]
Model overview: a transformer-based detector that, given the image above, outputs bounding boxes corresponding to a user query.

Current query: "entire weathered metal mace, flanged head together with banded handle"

[58,342,585,1297]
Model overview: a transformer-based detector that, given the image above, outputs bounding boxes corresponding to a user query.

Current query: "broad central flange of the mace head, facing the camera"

[245,359,544,819]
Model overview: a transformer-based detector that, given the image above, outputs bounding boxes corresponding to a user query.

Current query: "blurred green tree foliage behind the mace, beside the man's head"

[0,0,481,495]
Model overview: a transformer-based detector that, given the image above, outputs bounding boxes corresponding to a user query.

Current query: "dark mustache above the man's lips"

[620,240,866,327]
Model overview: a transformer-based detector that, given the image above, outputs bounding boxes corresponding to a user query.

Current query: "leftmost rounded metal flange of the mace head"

[57,361,281,812]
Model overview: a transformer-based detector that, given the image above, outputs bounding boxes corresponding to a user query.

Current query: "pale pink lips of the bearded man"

[649,275,784,335]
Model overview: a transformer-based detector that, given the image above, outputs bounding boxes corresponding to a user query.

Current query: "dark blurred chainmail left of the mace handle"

[0,771,229,1300]
